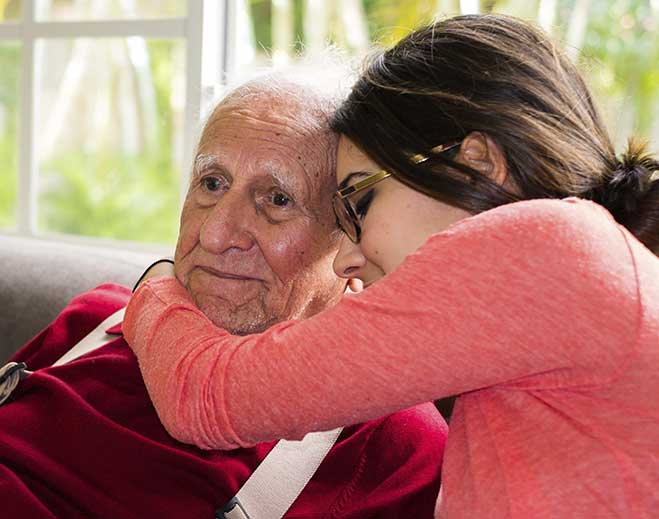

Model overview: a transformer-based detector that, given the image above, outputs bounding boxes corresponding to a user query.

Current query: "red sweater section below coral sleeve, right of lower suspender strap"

[296,404,448,519]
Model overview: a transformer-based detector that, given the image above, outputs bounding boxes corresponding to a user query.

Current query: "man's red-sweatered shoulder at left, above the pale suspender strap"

[11,283,131,369]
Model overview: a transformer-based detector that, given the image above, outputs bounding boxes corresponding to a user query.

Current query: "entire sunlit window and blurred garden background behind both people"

[0,0,659,244]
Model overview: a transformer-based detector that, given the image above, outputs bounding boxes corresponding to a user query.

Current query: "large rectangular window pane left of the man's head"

[36,37,185,243]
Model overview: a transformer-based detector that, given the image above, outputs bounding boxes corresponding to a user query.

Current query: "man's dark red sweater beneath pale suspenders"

[0,285,447,519]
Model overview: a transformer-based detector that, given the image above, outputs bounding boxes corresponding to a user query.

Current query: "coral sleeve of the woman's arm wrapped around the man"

[124,200,639,449]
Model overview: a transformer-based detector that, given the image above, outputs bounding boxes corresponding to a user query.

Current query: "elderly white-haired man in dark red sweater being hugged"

[0,78,446,519]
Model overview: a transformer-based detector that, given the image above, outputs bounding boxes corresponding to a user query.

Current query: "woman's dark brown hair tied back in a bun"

[332,15,659,254]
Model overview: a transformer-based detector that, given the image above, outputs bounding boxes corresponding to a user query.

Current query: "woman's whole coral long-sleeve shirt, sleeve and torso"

[124,199,659,519]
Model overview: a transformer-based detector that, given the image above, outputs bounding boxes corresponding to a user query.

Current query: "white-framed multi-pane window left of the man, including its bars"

[0,0,203,247]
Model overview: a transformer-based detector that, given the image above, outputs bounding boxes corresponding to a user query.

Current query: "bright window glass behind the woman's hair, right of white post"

[241,0,659,149]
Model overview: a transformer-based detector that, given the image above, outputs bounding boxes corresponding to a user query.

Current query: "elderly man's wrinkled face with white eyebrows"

[176,94,345,334]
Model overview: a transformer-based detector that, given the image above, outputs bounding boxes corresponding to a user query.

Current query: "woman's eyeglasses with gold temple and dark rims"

[332,141,462,243]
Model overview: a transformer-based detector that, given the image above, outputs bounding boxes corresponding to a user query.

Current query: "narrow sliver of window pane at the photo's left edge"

[0,41,21,229]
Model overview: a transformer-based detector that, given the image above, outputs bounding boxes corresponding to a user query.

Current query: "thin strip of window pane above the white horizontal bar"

[35,0,187,21]
